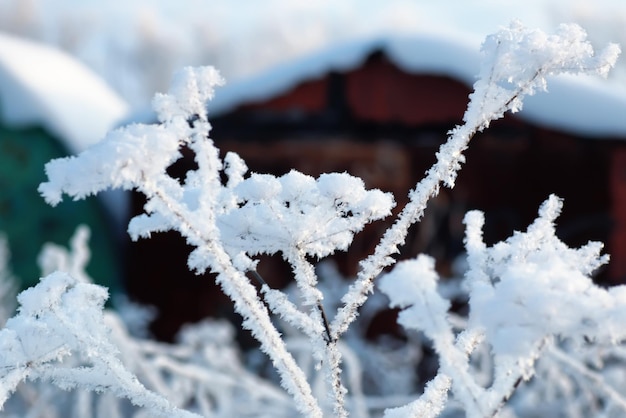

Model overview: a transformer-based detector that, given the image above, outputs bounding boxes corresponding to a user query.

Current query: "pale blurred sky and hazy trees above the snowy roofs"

[0,0,626,108]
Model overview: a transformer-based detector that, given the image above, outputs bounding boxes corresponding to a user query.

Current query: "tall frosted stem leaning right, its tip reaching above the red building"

[332,22,620,338]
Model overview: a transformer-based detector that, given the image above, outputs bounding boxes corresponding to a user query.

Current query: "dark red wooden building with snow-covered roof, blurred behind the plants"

[128,38,626,338]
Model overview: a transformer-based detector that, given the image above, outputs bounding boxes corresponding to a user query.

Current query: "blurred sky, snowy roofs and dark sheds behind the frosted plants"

[0,0,626,339]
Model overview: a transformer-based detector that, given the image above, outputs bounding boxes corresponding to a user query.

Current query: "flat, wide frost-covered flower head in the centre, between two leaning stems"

[218,171,394,258]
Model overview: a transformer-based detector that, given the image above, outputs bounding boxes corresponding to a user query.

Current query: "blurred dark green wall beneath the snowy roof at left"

[0,125,121,291]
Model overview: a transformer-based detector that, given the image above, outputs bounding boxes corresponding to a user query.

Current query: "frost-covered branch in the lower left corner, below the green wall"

[0,273,198,417]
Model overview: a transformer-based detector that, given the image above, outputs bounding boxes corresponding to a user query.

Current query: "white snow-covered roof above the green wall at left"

[0,33,129,153]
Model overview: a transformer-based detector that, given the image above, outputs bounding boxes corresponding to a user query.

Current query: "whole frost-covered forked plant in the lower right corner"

[380,196,626,417]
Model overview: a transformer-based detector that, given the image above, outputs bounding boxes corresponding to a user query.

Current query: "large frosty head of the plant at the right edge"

[465,195,626,355]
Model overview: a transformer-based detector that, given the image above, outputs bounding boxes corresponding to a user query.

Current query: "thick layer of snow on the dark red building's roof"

[209,34,626,138]
